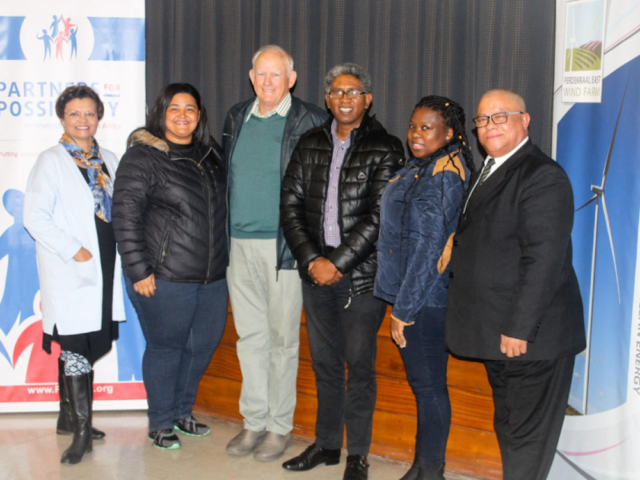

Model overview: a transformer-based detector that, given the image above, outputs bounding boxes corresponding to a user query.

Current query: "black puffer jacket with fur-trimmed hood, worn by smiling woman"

[112,129,228,283]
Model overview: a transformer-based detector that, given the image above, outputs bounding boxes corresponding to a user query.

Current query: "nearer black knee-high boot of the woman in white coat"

[60,374,93,465]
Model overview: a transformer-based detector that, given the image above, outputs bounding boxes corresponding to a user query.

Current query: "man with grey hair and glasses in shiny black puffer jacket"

[280,63,403,480]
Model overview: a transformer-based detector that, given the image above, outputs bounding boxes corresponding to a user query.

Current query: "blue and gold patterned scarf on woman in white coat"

[60,133,113,223]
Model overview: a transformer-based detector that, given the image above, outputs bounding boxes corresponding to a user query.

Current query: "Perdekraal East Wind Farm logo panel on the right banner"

[562,0,607,103]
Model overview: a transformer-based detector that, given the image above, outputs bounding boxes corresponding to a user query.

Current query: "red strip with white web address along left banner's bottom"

[0,381,147,403]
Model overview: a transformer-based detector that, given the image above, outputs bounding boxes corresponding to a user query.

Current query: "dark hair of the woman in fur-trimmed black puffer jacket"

[145,83,211,146]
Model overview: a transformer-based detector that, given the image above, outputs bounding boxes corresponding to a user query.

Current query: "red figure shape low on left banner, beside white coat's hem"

[12,320,60,384]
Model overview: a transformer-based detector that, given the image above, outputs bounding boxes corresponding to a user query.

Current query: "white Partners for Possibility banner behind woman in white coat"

[0,0,146,412]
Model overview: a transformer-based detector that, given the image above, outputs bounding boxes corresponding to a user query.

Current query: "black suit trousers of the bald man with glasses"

[485,355,575,480]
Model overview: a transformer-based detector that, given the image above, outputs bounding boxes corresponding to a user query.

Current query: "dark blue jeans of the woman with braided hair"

[400,307,451,465]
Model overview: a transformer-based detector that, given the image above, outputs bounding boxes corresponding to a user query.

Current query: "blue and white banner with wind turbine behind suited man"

[549,0,640,480]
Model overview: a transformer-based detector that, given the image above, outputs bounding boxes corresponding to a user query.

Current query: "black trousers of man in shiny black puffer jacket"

[302,276,387,455]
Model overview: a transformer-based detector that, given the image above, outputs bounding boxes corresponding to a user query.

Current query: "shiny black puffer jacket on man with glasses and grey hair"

[280,115,403,295]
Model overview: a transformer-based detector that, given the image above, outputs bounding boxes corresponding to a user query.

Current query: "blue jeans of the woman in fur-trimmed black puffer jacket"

[126,278,228,431]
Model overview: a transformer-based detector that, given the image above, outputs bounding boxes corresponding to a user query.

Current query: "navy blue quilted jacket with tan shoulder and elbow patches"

[374,145,469,324]
